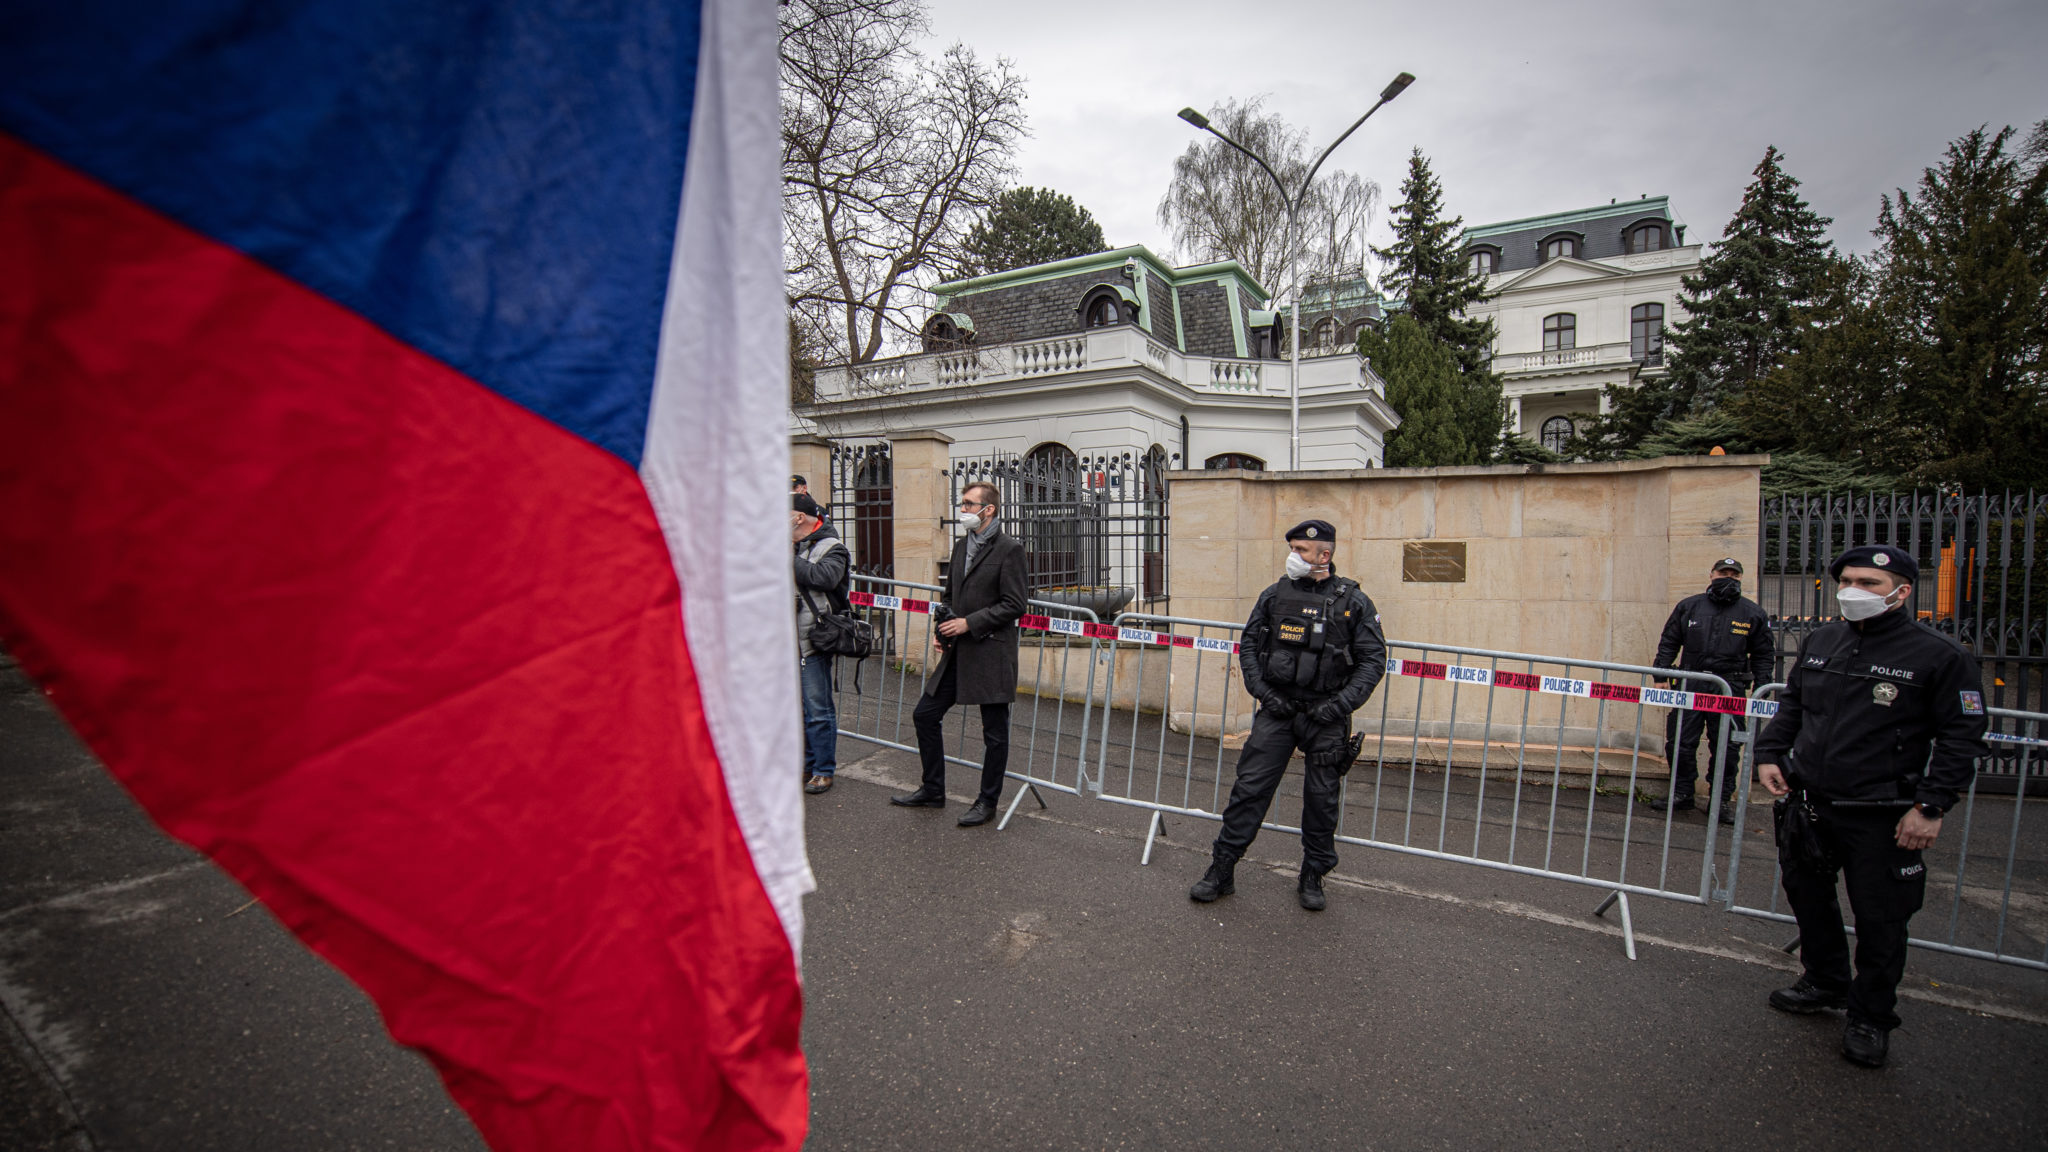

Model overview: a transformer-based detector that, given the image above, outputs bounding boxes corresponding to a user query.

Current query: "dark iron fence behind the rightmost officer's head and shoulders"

[1755,490,2048,711]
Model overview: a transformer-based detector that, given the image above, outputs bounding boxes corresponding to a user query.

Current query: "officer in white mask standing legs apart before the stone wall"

[1188,521,1386,912]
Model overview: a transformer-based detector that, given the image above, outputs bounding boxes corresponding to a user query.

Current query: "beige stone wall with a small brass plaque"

[1167,455,1767,750]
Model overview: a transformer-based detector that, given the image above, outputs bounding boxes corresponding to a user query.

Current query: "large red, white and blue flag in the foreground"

[0,0,811,1150]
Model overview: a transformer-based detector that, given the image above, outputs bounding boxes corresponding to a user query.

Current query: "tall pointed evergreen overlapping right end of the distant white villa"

[1662,146,1833,412]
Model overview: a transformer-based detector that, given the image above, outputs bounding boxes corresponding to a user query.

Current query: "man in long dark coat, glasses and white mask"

[889,484,1028,828]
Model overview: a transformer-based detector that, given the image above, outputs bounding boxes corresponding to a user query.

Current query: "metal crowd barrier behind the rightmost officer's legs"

[1726,685,2048,970]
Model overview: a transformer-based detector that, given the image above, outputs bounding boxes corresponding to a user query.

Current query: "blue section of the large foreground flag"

[0,0,700,465]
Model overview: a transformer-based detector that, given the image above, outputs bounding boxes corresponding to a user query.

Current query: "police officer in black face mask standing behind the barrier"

[1651,556,1776,824]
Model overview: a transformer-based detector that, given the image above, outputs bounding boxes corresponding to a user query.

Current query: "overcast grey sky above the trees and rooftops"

[932,0,2048,268]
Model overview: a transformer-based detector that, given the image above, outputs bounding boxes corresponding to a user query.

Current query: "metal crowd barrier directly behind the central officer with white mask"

[1096,613,1749,959]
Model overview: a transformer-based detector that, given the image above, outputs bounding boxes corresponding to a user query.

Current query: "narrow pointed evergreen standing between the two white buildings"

[1372,148,1507,463]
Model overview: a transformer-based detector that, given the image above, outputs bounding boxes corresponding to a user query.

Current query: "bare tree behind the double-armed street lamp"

[1159,98,1380,291]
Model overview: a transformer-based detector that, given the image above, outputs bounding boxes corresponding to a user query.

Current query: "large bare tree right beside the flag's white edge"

[782,0,1024,363]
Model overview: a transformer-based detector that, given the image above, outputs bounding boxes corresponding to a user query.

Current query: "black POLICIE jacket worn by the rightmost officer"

[1757,609,1989,808]
